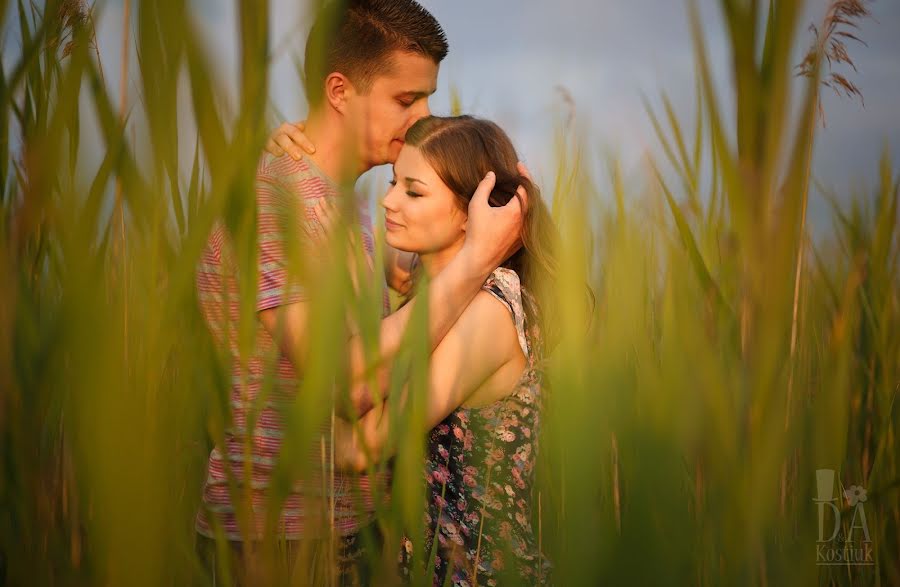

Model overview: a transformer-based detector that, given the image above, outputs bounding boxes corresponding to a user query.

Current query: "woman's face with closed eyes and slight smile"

[381,145,467,254]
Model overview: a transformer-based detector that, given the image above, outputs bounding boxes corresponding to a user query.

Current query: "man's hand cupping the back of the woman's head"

[463,163,530,272]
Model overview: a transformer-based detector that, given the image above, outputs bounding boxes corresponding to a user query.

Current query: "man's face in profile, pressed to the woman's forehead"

[351,51,438,167]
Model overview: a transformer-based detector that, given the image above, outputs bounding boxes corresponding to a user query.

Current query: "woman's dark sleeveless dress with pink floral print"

[400,268,549,586]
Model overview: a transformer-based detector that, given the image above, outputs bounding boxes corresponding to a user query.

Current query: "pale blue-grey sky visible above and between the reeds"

[4,0,900,239]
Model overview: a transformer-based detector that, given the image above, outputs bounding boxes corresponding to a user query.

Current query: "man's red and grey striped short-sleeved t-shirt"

[196,154,389,540]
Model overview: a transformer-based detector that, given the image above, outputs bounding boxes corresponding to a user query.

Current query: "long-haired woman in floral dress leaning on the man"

[326,116,557,585]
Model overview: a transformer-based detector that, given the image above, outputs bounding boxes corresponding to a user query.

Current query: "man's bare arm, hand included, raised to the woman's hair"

[259,173,527,414]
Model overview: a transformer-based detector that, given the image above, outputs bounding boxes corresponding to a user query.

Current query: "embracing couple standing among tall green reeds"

[196,0,557,585]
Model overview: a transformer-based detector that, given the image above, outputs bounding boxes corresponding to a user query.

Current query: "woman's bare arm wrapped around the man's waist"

[335,291,524,471]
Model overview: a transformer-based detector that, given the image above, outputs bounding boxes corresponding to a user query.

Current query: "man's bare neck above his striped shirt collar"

[304,113,370,185]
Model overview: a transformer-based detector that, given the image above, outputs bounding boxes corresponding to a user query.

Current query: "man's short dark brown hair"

[304,0,447,106]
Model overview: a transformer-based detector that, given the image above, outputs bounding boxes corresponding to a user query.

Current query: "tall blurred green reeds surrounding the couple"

[0,0,900,585]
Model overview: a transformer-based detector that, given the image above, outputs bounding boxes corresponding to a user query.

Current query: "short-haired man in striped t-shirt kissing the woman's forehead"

[196,0,522,582]
